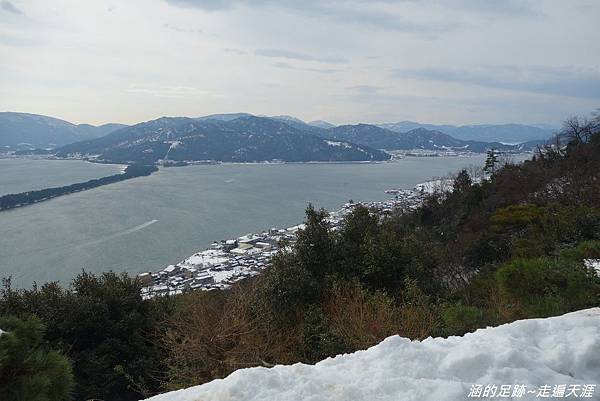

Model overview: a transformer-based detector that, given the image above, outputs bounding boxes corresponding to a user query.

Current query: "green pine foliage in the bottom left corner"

[0,317,73,401]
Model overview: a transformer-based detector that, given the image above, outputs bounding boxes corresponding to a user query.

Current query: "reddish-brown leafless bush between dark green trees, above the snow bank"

[161,283,292,390]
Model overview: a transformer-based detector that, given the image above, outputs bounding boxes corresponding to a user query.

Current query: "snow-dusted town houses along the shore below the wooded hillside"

[138,183,434,298]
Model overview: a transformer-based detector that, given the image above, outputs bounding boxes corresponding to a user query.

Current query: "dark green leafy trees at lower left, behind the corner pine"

[0,272,170,401]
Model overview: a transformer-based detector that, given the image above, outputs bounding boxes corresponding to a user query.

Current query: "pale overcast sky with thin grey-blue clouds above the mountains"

[0,0,600,125]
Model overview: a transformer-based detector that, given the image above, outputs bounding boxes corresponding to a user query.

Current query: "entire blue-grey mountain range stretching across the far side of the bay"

[0,113,552,163]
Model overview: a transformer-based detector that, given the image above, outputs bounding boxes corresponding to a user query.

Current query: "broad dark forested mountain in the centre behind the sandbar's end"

[57,116,390,163]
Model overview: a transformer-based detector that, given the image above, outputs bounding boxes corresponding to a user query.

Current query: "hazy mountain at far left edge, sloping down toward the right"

[0,112,124,152]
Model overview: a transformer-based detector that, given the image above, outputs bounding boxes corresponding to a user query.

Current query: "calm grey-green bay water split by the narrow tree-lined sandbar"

[0,156,492,287]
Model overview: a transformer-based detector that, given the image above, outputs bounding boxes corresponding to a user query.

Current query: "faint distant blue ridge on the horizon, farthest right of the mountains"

[377,121,556,143]
